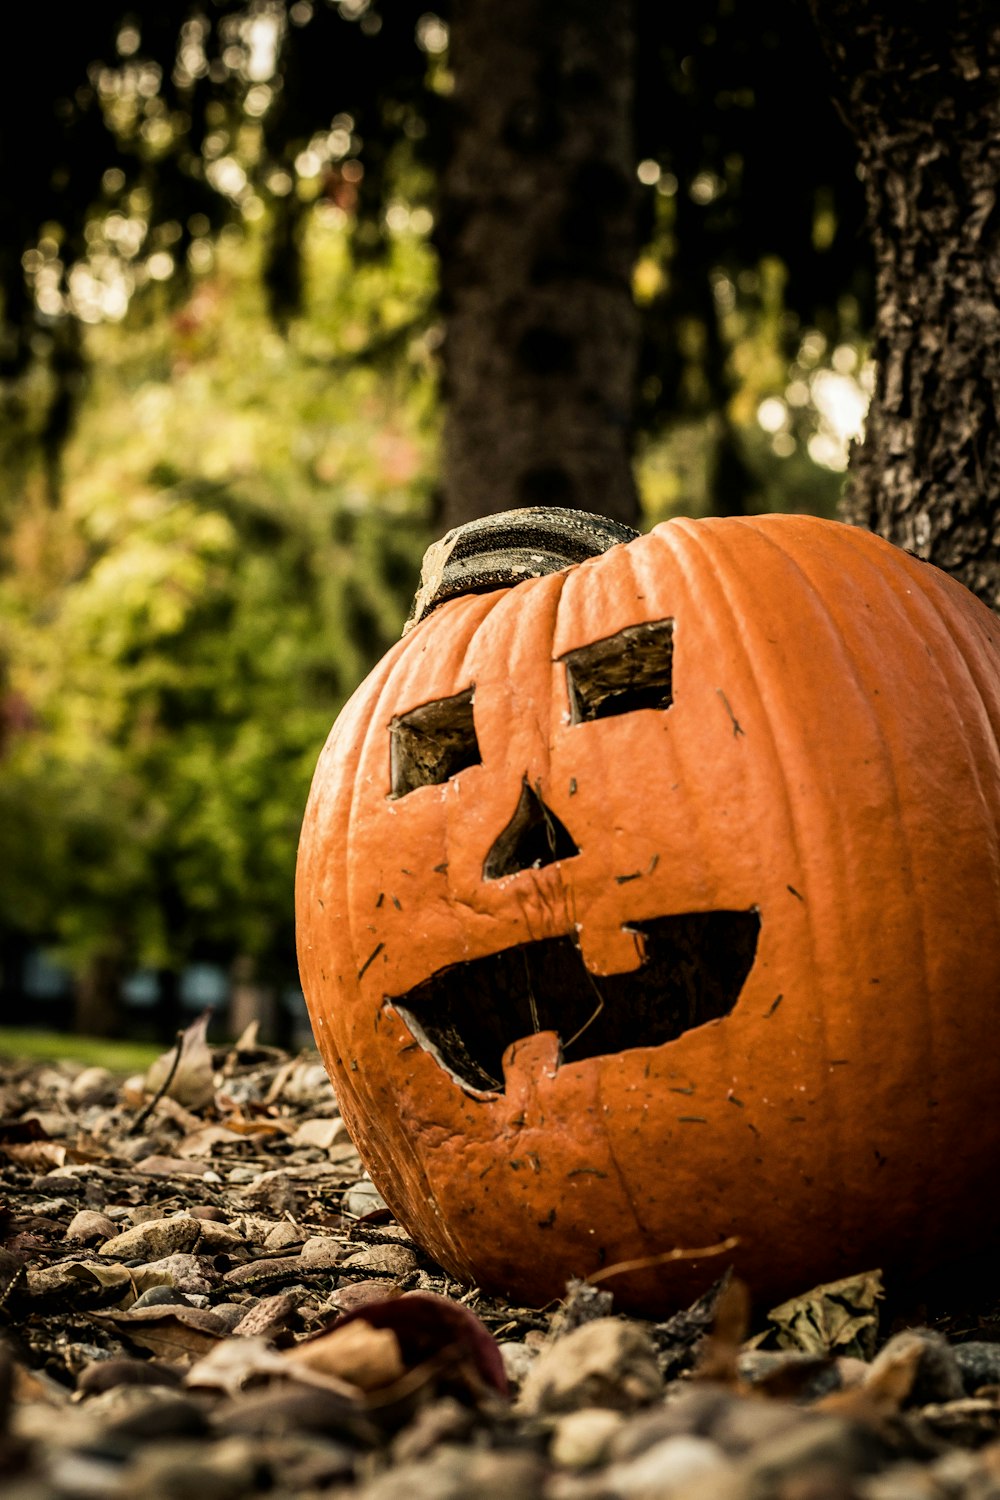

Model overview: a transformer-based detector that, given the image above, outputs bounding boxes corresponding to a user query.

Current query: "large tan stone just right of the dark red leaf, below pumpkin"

[519,1317,663,1413]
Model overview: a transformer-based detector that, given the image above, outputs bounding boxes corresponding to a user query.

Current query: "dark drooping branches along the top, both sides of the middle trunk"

[0,0,873,486]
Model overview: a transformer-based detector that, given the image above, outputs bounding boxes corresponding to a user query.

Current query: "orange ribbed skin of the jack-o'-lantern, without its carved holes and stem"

[297,516,1000,1314]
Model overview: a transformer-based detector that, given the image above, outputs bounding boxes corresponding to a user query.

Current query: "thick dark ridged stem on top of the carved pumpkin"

[403,506,639,635]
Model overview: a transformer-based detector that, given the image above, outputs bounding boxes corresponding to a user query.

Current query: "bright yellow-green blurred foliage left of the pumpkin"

[0,221,435,971]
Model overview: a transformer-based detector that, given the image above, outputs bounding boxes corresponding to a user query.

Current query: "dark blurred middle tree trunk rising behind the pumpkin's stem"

[438,0,639,527]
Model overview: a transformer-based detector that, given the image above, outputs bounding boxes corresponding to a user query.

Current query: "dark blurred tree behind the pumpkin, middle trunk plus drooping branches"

[0,0,868,522]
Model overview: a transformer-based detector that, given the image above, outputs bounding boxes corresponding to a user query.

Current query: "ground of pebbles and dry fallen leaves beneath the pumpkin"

[0,1023,1000,1500]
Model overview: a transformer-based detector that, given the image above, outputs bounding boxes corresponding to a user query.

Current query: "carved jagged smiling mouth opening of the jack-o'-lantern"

[387,909,760,1094]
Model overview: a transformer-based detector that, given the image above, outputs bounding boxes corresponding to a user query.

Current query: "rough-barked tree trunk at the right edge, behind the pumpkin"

[811,0,1000,609]
